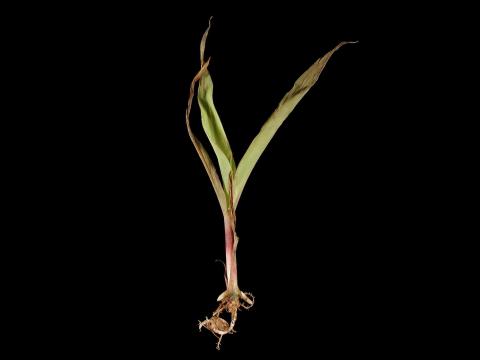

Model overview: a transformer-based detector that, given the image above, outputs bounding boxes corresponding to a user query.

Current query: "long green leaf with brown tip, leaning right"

[233,42,356,208]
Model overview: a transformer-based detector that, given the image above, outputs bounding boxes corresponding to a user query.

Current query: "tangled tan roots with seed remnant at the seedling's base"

[198,290,255,350]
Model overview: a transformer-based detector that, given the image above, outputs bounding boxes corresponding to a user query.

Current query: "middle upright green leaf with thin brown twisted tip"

[197,18,235,195]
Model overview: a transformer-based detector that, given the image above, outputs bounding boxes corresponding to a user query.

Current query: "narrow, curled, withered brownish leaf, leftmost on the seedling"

[185,60,227,214]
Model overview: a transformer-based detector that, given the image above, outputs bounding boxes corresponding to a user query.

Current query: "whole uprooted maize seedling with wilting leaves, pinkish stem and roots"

[186,19,349,349]
